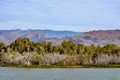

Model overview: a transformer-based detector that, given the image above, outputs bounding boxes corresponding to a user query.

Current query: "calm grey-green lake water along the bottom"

[0,67,120,80]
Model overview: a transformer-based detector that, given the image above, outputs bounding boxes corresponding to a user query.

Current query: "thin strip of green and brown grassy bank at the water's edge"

[0,64,120,68]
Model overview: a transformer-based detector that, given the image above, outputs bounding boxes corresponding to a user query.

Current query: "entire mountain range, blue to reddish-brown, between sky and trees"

[0,29,120,46]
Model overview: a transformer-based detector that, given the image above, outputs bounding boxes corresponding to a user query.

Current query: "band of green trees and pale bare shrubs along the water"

[0,38,120,66]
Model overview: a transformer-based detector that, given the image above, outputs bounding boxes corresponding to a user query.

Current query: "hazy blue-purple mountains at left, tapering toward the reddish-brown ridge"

[0,29,80,44]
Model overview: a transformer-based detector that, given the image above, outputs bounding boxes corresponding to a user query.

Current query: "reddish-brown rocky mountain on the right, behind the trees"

[66,30,120,45]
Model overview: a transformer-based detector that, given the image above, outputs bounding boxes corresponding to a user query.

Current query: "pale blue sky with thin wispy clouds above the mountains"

[0,0,120,32]
